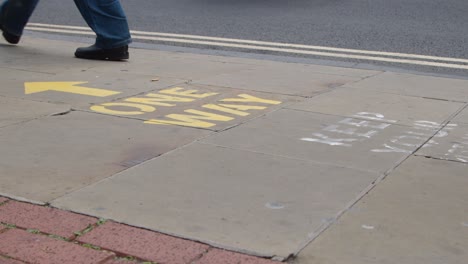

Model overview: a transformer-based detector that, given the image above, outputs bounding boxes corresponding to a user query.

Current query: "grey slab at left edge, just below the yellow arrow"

[0,96,71,128]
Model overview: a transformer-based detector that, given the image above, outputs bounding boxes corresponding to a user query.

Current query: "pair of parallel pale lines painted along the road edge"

[26,24,468,69]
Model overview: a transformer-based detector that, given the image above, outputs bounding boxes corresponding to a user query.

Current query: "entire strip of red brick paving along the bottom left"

[0,197,278,264]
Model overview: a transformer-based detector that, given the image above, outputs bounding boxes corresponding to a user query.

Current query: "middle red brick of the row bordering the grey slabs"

[78,222,209,264]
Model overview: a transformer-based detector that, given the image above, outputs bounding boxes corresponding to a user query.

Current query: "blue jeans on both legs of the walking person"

[0,0,132,49]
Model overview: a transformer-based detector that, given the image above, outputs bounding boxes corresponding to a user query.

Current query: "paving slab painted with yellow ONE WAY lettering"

[90,84,303,130]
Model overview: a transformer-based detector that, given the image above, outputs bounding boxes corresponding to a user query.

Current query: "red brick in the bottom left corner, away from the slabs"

[0,229,114,264]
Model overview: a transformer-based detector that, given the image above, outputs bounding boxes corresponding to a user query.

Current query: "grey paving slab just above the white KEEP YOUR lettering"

[290,87,464,126]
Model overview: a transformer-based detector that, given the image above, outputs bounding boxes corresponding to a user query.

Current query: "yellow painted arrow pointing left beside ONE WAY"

[24,82,120,97]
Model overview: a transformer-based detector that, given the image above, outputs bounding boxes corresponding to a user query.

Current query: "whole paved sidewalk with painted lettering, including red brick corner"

[0,37,468,264]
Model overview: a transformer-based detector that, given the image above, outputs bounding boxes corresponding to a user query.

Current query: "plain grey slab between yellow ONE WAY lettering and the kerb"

[194,64,362,96]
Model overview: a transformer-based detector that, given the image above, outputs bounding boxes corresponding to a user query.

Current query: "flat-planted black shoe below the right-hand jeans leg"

[75,45,129,61]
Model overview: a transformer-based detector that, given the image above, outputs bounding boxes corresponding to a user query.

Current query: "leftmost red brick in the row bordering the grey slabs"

[0,201,97,238]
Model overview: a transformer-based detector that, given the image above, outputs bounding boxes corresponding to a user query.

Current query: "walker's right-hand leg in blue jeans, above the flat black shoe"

[74,0,131,49]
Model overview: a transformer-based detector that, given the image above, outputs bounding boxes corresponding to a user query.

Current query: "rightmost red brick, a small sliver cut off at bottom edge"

[193,248,279,264]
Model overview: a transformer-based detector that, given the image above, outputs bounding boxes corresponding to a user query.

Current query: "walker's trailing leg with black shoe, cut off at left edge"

[0,0,39,44]
